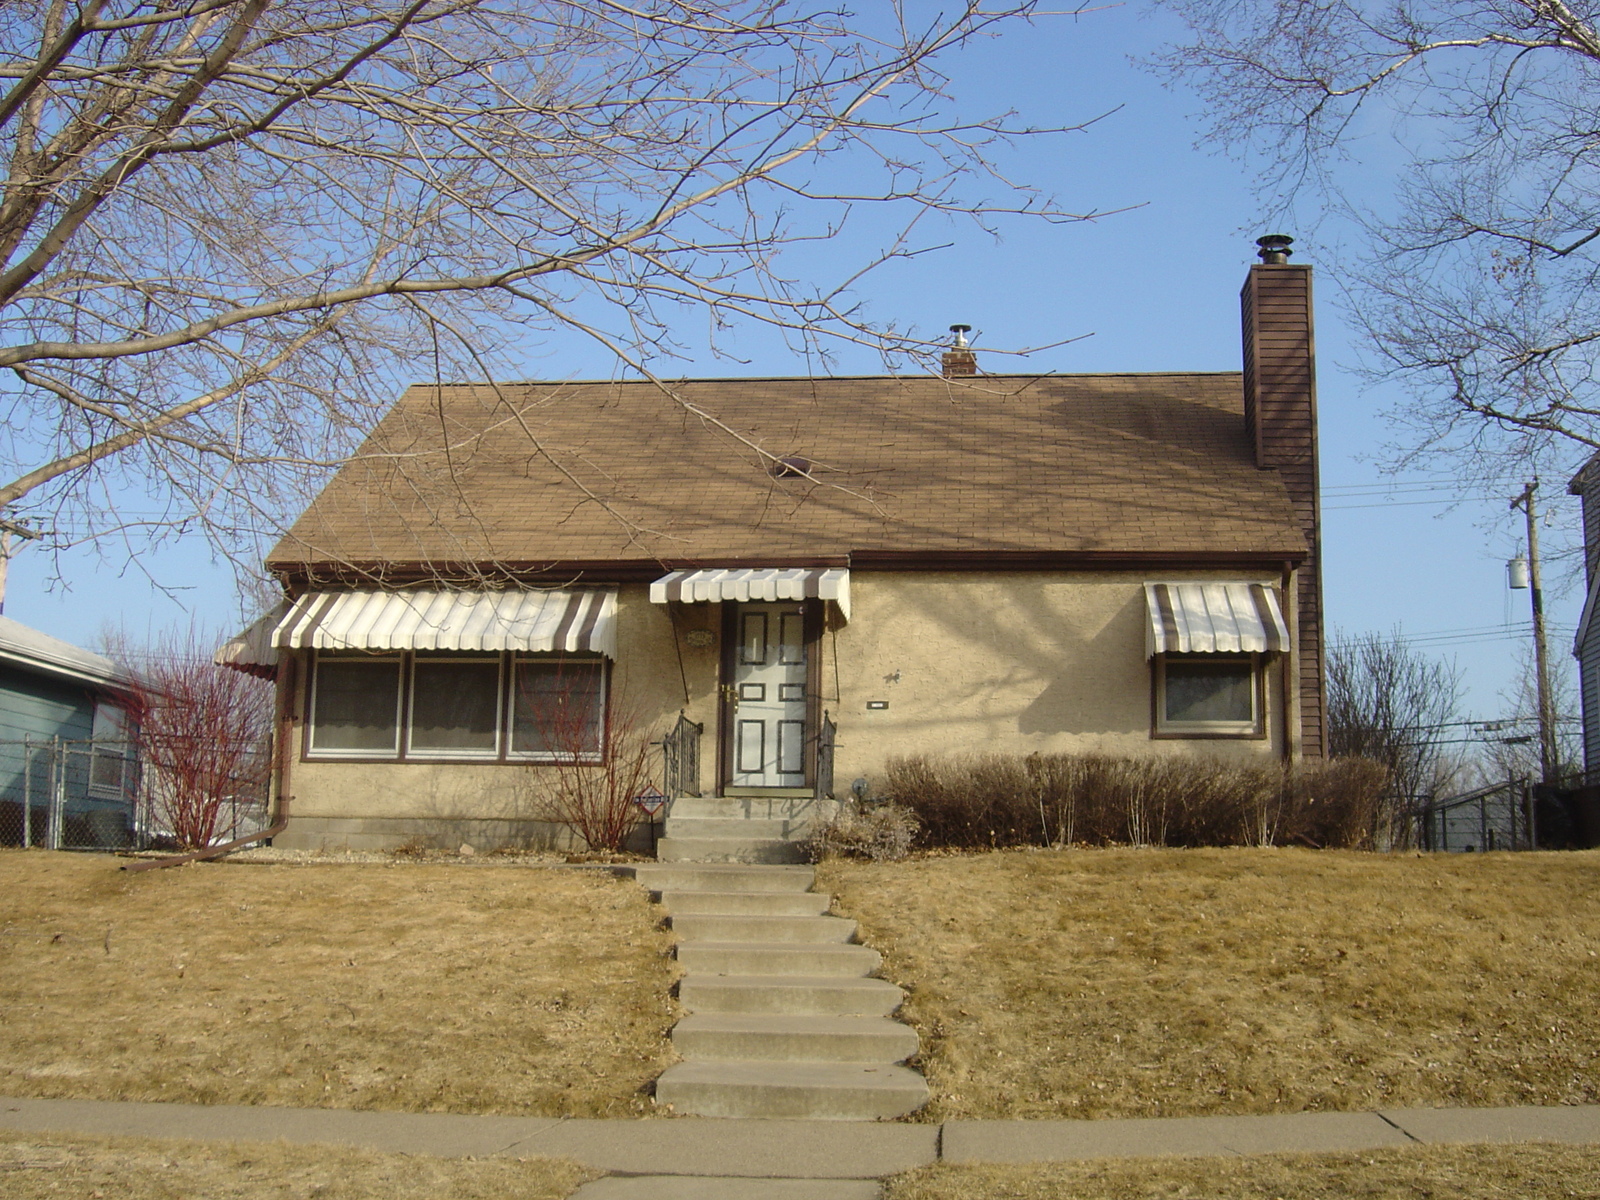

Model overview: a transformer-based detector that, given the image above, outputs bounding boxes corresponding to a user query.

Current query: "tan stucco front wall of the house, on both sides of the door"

[283,571,1283,848]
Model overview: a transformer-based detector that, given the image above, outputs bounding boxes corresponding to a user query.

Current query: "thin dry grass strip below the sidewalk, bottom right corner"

[885,1146,1600,1200]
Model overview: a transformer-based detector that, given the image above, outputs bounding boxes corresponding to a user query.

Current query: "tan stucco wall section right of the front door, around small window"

[822,571,1283,789]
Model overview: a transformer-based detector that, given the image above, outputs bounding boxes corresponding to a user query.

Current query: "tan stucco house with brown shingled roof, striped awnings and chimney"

[219,237,1325,846]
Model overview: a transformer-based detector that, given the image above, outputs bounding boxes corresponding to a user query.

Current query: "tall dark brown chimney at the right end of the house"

[1238,234,1328,758]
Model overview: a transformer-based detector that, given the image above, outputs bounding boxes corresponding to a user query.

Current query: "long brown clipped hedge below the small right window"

[882,754,1389,848]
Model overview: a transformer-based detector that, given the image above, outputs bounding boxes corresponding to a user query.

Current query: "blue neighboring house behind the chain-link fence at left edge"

[0,616,138,848]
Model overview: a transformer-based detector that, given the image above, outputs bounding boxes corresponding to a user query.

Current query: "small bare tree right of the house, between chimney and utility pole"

[1328,634,1461,809]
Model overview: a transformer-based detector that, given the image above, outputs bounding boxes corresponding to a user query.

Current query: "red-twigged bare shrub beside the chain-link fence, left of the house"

[120,630,272,850]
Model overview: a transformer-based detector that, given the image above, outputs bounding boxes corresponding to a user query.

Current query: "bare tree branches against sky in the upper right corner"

[1160,0,1600,480]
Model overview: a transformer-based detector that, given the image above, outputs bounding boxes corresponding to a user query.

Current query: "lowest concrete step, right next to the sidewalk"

[656,1062,928,1120]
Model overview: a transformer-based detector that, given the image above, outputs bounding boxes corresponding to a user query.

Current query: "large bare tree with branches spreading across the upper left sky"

[0,0,1094,572]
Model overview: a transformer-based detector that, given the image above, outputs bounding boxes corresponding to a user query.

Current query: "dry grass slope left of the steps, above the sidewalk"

[0,851,675,1117]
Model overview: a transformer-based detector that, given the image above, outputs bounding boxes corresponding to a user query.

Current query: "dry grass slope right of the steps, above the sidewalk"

[818,850,1600,1120]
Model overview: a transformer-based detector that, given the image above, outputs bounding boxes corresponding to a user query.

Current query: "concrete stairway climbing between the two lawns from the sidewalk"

[638,862,928,1120]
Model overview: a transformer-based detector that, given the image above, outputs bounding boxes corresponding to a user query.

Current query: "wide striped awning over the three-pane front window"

[272,587,616,659]
